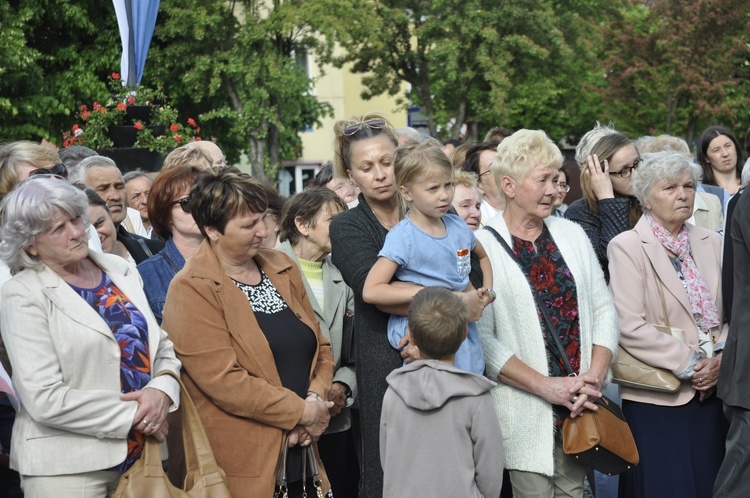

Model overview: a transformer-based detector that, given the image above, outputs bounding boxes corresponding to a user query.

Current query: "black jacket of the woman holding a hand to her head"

[565,197,638,283]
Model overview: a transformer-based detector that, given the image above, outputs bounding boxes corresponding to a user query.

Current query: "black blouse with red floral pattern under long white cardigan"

[512,225,581,426]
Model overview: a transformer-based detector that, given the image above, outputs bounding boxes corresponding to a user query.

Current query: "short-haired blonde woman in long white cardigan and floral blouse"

[477,130,617,497]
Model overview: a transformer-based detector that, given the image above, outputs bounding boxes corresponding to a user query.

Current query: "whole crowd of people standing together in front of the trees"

[0,113,750,498]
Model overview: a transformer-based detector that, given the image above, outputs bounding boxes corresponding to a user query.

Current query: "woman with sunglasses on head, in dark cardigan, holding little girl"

[330,113,482,498]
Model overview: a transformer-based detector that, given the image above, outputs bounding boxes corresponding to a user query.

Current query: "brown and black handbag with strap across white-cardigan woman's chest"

[484,226,639,475]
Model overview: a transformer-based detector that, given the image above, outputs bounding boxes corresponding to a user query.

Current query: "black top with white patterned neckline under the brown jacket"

[233,268,318,482]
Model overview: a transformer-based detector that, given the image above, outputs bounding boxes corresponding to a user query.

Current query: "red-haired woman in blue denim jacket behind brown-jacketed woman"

[138,165,203,323]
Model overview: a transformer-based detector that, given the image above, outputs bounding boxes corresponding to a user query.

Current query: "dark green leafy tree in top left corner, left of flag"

[0,0,120,143]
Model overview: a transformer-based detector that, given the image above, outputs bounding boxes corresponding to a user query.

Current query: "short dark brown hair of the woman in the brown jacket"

[190,167,268,237]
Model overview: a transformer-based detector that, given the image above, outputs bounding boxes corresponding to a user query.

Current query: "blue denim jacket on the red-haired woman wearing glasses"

[138,237,185,325]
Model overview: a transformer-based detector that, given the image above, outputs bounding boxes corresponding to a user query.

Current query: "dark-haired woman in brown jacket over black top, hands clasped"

[163,168,333,498]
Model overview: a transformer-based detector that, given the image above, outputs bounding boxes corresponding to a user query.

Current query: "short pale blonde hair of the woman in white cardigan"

[490,130,563,198]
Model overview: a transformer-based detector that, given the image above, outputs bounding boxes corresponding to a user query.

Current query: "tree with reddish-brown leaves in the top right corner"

[602,0,750,142]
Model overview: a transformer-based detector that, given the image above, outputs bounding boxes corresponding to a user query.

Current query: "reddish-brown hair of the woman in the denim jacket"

[146,166,201,240]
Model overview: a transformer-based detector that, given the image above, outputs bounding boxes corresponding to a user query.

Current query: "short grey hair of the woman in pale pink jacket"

[632,151,703,208]
